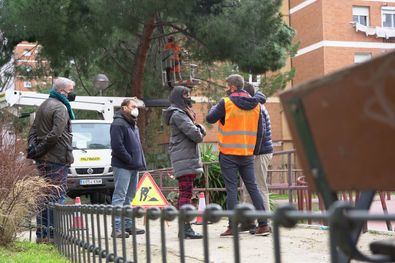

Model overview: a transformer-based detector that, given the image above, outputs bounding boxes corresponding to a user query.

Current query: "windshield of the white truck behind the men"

[72,123,111,149]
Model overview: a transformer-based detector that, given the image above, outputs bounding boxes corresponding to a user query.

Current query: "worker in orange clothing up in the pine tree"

[162,36,182,88]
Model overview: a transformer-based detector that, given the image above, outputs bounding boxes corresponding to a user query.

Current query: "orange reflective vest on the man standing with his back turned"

[218,98,260,156]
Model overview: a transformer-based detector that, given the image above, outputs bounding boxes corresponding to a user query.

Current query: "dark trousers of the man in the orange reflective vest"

[219,153,267,226]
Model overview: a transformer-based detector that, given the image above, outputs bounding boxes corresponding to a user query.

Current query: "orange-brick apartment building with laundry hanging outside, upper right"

[289,0,395,86]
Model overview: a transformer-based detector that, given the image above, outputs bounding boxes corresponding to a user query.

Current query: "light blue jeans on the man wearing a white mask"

[111,167,139,230]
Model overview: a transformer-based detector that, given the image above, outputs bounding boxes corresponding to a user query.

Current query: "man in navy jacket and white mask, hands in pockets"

[110,99,146,238]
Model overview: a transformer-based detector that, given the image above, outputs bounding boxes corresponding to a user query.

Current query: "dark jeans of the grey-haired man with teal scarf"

[36,161,67,238]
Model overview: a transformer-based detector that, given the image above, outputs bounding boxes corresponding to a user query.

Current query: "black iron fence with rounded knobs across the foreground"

[33,201,395,263]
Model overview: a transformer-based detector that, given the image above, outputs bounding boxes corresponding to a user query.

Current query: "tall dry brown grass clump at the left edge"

[0,119,51,245]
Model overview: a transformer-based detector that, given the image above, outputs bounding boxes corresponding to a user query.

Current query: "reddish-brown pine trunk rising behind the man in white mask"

[132,15,155,148]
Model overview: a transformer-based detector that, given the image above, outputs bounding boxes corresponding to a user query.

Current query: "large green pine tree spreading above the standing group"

[0,0,294,97]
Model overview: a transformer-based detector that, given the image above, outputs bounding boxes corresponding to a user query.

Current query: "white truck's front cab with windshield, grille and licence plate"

[67,120,114,204]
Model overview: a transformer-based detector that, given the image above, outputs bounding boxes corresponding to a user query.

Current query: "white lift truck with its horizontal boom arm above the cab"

[5,90,147,204]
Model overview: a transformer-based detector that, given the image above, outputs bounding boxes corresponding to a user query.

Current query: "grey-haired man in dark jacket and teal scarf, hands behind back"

[27,77,75,243]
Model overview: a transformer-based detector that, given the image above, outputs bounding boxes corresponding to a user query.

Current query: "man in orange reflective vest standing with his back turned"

[206,74,271,237]
